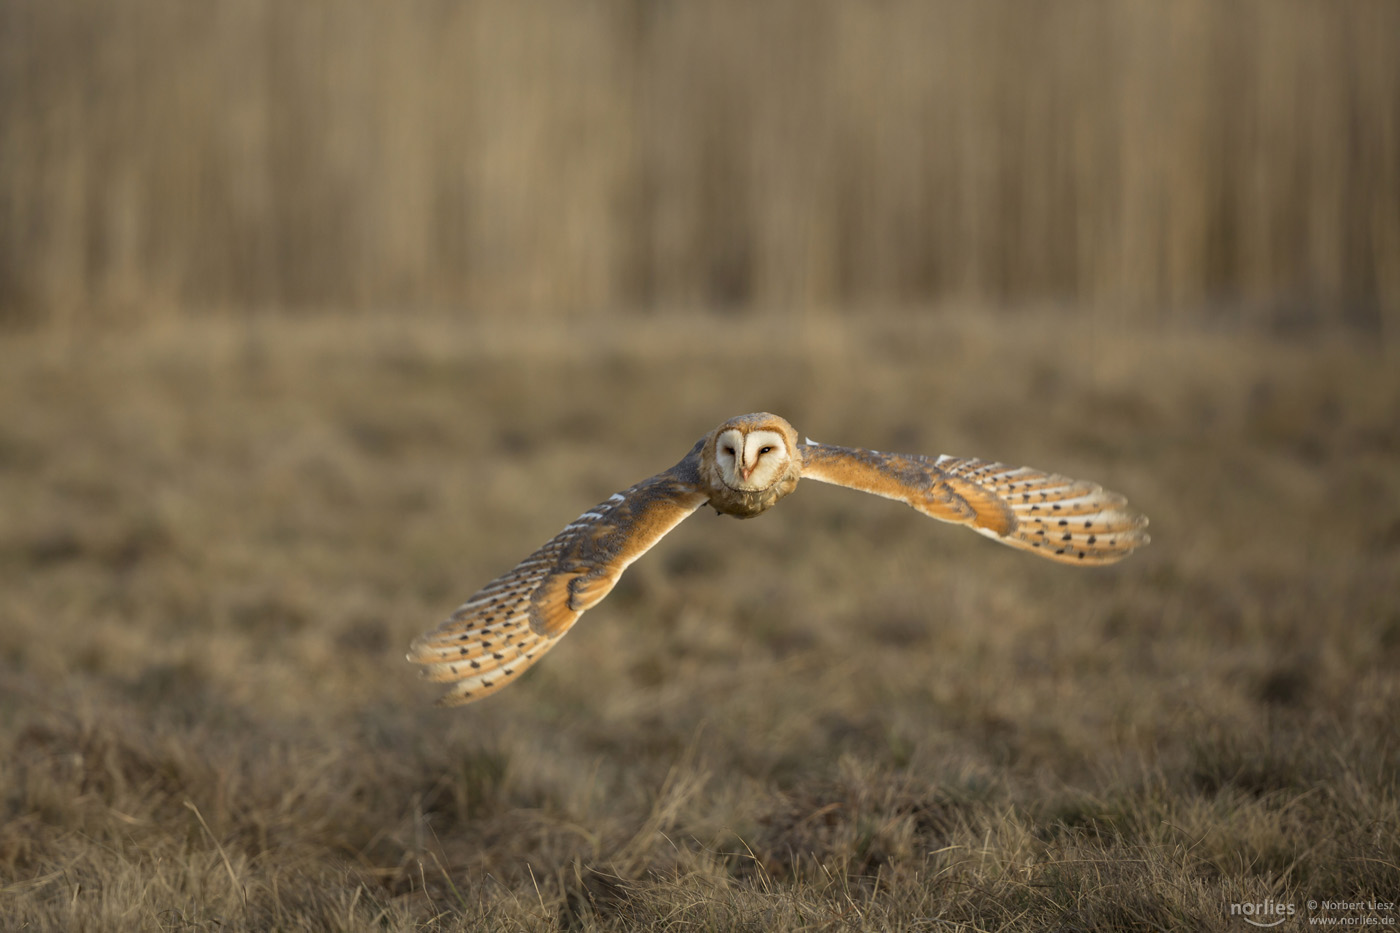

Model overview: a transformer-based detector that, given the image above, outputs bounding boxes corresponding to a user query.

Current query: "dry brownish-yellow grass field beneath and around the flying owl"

[0,310,1400,932]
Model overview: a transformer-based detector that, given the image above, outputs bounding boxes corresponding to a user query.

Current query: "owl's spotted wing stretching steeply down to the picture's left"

[409,444,708,706]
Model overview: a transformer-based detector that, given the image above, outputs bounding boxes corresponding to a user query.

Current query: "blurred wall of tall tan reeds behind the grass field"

[0,0,1400,329]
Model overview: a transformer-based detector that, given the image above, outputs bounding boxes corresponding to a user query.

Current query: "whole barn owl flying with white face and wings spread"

[407,412,1148,706]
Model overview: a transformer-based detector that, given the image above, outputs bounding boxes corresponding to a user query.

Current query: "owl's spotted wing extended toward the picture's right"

[799,441,1149,563]
